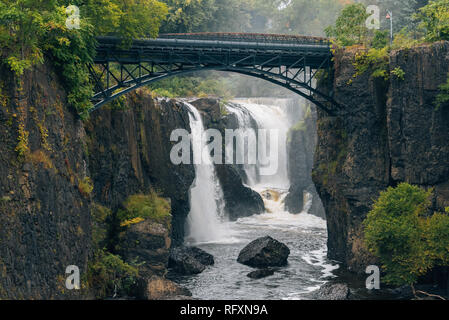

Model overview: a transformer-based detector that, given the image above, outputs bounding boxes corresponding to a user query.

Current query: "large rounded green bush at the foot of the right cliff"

[364,183,449,285]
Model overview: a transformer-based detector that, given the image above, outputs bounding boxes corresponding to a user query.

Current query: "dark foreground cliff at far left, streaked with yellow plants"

[0,66,91,299]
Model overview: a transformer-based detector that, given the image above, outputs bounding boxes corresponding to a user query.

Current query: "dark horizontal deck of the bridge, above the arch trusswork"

[95,34,331,69]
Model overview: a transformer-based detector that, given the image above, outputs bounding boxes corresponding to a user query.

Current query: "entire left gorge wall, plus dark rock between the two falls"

[0,64,263,299]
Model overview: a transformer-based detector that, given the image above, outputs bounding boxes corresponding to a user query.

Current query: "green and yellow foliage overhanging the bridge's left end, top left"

[0,0,167,116]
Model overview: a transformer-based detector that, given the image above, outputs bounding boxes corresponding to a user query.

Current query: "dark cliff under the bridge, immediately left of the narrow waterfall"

[86,90,195,244]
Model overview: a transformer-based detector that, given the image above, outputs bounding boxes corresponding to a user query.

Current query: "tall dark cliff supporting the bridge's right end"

[313,42,449,272]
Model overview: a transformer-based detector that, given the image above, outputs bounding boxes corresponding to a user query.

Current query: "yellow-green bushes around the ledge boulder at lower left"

[85,191,171,298]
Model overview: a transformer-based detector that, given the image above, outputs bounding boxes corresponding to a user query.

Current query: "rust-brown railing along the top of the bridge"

[158,32,330,45]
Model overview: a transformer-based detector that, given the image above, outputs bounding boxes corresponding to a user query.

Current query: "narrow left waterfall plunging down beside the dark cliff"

[184,102,226,243]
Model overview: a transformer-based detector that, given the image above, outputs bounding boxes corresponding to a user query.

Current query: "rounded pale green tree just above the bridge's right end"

[325,3,369,46]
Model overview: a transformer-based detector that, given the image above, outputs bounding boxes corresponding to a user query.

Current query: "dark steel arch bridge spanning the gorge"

[89,33,340,114]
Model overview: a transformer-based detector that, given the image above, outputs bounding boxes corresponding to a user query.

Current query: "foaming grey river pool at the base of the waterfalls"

[175,190,338,300]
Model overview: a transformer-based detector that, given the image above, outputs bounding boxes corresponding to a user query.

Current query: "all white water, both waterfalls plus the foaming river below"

[174,100,338,300]
